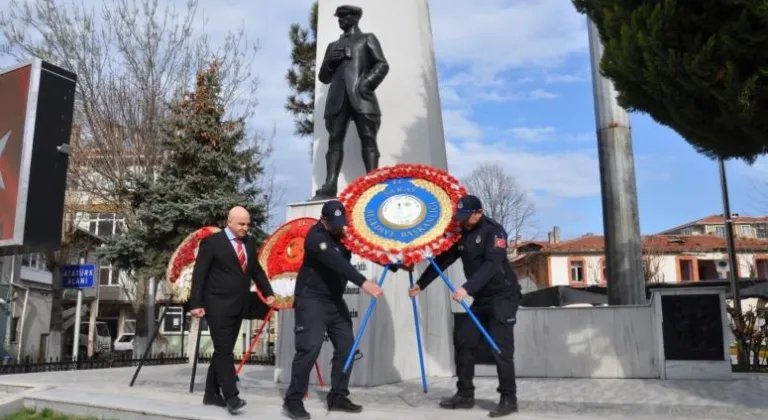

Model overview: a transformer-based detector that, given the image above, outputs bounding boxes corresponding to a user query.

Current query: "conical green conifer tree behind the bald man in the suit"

[102,62,265,351]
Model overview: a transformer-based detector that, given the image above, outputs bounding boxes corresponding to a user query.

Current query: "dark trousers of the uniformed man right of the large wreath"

[455,296,520,401]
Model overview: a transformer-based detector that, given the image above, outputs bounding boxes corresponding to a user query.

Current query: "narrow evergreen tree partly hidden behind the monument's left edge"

[285,2,318,155]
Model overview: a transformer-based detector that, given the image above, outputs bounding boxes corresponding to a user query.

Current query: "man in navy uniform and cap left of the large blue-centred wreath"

[283,200,382,419]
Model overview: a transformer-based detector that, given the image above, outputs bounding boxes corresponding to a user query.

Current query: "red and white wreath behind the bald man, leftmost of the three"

[166,226,221,303]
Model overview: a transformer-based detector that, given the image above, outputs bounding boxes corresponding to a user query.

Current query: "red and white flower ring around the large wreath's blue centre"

[339,163,466,265]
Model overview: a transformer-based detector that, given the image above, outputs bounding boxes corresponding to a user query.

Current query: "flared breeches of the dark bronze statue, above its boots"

[325,97,381,157]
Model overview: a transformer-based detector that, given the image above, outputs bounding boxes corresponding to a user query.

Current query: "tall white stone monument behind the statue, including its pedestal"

[275,0,464,386]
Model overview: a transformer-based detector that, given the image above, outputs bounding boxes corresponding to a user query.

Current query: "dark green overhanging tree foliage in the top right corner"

[573,0,768,162]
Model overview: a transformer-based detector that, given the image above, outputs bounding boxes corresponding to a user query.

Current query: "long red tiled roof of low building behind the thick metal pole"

[541,235,768,253]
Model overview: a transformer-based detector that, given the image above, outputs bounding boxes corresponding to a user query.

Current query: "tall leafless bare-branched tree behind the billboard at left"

[0,0,256,356]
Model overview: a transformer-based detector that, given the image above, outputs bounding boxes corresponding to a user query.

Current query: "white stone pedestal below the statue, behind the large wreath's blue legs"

[275,201,455,386]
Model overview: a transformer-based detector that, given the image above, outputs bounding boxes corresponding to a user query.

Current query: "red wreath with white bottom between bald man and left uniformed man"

[255,217,317,309]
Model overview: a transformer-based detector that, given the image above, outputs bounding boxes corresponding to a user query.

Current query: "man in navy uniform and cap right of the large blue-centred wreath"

[409,195,521,417]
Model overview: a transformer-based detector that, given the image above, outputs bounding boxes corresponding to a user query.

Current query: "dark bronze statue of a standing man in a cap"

[314,6,389,199]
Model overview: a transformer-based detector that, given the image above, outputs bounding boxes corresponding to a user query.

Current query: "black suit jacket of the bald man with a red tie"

[189,230,273,317]
